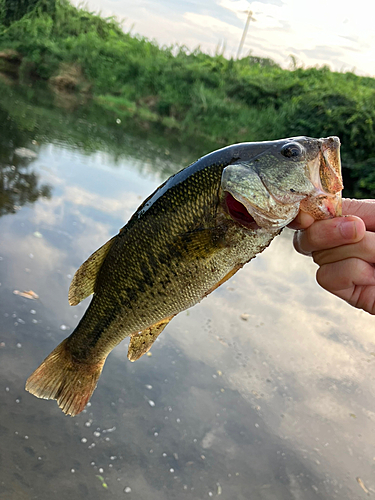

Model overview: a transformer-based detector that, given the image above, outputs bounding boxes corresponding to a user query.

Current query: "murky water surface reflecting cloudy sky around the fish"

[0,87,375,500]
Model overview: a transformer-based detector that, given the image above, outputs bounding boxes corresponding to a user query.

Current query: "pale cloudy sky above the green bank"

[75,0,375,76]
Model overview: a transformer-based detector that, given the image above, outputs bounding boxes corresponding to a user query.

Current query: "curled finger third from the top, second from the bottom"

[316,258,375,292]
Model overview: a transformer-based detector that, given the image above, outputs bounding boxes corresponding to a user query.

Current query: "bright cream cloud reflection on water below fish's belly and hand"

[169,231,374,484]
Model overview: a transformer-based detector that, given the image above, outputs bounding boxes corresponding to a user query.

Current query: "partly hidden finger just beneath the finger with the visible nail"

[312,231,375,266]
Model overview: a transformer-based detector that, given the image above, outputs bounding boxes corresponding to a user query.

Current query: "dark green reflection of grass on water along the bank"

[0,82,212,185]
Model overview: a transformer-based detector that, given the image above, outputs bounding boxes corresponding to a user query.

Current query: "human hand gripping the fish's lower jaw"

[289,199,375,314]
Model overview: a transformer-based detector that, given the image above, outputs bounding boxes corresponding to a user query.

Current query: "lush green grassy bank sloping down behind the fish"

[0,0,375,196]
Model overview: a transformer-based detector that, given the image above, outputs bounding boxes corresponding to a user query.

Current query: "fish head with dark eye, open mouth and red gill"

[220,137,343,229]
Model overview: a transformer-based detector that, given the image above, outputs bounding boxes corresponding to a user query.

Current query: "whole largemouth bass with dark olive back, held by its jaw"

[26,137,343,416]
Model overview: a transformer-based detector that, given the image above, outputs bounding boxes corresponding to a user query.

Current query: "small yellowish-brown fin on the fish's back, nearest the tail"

[68,236,116,306]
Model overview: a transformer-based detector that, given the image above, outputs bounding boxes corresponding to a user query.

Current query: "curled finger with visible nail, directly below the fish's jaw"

[293,215,366,255]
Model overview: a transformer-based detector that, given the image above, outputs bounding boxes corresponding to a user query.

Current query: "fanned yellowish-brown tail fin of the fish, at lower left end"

[26,339,105,417]
